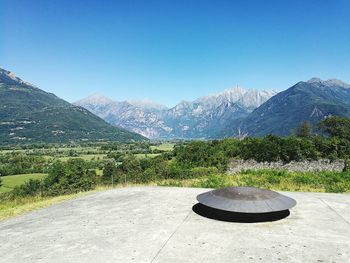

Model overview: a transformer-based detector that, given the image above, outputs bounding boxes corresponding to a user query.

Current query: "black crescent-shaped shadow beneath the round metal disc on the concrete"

[192,203,290,223]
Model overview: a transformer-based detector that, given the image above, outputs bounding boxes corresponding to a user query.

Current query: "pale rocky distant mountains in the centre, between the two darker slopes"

[75,87,276,139]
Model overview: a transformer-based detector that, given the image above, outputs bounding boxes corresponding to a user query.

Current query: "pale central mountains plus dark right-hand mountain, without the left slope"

[75,78,350,139]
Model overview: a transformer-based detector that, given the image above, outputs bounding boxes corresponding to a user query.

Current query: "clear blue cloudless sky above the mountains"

[0,0,350,106]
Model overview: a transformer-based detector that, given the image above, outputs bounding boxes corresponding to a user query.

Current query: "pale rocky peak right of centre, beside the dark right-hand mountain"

[165,87,276,139]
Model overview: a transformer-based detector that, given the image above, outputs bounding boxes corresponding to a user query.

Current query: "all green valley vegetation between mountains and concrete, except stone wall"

[0,117,350,221]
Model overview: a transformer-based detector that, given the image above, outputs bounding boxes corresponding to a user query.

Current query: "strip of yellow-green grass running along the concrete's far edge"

[0,170,350,223]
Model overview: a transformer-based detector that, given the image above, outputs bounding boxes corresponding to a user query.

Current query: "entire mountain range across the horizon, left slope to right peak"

[0,66,350,144]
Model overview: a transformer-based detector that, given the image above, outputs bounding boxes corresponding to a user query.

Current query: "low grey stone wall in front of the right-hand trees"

[228,159,345,173]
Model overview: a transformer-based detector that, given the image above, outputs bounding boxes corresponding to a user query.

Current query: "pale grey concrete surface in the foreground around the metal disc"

[0,187,350,263]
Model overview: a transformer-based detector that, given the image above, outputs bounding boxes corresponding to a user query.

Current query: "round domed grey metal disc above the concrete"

[197,187,296,213]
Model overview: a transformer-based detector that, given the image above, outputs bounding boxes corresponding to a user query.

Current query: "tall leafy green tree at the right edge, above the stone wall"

[318,116,350,140]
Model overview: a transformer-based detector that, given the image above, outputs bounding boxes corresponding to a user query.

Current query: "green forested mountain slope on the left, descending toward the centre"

[0,69,143,144]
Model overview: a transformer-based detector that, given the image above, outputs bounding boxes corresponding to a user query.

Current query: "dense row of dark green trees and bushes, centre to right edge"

[102,117,350,187]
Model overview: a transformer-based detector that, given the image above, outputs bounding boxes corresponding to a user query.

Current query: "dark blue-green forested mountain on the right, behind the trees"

[230,78,350,136]
